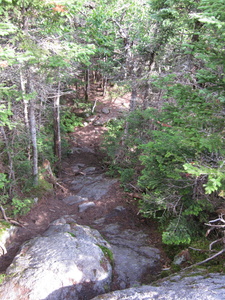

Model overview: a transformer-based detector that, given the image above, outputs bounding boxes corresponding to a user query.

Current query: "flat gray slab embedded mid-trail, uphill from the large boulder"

[70,175,117,201]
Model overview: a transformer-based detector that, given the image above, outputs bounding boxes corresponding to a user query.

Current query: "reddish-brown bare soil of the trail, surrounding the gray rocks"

[0,85,171,273]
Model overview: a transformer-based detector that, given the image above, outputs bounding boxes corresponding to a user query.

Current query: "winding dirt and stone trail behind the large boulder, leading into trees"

[0,87,168,289]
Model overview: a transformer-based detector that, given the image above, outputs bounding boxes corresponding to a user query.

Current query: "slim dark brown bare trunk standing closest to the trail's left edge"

[53,82,62,169]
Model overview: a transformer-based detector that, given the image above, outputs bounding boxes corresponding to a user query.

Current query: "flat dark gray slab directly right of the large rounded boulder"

[101,224,161,289]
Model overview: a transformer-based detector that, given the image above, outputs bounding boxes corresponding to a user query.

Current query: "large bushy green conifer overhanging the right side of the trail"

[103,82,225,245]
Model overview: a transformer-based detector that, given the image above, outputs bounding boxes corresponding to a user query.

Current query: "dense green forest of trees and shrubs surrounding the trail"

[0,0,225,244]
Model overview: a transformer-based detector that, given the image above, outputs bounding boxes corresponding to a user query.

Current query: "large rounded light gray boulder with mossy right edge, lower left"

[0,216,112,300]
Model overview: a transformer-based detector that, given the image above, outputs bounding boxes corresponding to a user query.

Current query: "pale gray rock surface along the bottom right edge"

[93,271,225,300]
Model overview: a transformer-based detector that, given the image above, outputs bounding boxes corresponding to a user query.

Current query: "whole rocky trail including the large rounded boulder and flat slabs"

[0,99,165,300]
